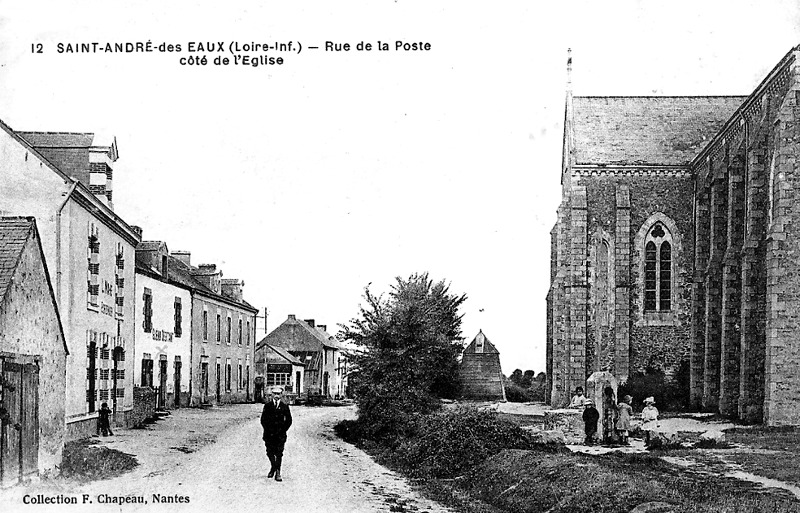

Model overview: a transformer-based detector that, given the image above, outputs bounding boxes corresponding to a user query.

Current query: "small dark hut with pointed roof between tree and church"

[459,330,506,401]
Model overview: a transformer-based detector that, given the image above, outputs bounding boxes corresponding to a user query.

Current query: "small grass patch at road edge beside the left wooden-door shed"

[61,439,139,481]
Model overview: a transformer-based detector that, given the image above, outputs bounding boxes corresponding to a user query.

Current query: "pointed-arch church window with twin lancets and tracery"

[644,223,672,312]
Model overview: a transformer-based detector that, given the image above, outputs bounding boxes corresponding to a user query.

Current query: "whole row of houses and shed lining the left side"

[0,121,284,484]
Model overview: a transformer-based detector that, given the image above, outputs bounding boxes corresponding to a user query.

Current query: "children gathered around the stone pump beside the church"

[570,387,658,445]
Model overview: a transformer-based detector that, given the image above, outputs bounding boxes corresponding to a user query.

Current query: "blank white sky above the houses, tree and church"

[0,0,800,374]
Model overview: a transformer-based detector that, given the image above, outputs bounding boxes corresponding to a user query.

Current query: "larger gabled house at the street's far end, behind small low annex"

[259,315,341,397]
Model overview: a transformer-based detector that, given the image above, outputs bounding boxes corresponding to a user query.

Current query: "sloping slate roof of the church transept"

[572,96,747,166]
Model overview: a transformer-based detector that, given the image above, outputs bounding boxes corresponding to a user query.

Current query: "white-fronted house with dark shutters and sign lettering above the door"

[133,241,192,409]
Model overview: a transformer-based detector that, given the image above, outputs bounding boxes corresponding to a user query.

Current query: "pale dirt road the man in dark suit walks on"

[0,404,456,513]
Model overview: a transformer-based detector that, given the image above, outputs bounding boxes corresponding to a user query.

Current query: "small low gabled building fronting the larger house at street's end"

[255,340,306,401]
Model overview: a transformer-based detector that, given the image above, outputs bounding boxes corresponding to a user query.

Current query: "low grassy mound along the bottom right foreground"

[455,450,800,513]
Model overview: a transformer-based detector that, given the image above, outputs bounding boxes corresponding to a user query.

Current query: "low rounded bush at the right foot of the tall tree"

[397,408,534,477]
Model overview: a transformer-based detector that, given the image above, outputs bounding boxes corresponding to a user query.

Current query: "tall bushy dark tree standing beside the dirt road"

[340,273,467,440]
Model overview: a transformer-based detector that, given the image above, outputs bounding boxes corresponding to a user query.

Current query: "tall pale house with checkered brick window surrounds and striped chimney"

[0,125,140,440]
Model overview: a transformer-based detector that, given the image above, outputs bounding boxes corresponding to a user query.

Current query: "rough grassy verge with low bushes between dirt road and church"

[337,410,800,513]
